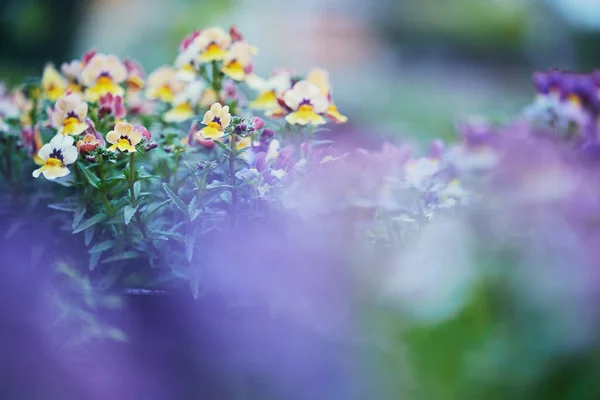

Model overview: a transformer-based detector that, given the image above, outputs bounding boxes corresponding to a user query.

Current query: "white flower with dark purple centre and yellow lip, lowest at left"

[32,135,77,180]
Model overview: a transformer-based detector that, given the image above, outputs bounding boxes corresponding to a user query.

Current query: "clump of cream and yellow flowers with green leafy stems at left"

[0,27,346,292]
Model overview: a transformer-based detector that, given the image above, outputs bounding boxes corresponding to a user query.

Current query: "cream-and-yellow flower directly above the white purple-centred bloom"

[50,93,88,135]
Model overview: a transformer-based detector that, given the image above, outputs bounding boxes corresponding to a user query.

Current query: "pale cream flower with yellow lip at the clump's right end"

[283,81,329,125]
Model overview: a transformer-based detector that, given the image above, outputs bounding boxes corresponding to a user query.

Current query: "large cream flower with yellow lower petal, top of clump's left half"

[81,53,127,101]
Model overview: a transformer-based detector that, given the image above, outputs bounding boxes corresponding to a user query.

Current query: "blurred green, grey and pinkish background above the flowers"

[0,0,600,140]
